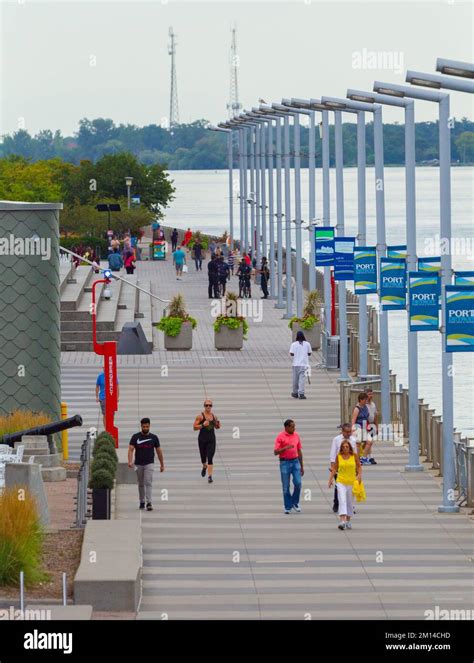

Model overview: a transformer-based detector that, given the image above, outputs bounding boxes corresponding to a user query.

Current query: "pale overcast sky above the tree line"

[0,0,474,135]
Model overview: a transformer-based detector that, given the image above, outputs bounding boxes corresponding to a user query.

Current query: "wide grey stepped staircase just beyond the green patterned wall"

[60,261,153,352]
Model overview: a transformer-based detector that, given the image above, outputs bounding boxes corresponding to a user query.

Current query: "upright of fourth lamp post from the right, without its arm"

[357,111,368,375]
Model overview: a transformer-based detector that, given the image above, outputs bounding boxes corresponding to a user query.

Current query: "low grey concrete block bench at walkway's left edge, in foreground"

[74,519,141,612]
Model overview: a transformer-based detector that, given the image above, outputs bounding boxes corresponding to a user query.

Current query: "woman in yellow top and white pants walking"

[328,440,362,529]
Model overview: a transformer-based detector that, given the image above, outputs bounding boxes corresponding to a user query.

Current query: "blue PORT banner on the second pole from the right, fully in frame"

[408,272,441,331]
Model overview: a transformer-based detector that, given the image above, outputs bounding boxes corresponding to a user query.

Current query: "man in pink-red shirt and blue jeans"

[273,419,304,514]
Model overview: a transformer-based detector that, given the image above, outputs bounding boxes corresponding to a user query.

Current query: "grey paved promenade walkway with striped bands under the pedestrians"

[63,256,474,620]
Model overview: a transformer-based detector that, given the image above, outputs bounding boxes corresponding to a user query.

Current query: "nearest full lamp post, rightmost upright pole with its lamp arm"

[374,81,459,513]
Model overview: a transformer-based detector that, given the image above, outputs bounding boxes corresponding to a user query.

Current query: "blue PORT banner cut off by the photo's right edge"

[445,285,474,352]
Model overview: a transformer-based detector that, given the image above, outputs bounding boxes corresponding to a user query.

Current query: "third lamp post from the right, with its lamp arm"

[321,97,391,418]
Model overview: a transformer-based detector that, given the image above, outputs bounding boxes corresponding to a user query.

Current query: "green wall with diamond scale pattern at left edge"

[0,202,62,419]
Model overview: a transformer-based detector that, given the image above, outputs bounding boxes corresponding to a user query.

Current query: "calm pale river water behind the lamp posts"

[166,167,474,436]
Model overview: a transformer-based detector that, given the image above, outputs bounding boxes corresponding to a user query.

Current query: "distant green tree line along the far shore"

[0,118,474,170]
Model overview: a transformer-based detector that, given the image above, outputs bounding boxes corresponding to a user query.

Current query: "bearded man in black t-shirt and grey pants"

[128,417,165,511]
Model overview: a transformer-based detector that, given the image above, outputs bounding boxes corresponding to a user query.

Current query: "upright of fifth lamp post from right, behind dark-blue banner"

[334,111,350,382]
